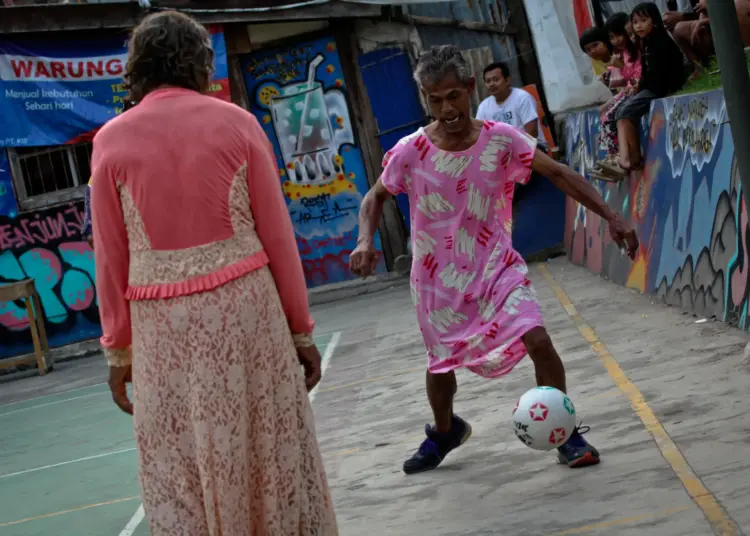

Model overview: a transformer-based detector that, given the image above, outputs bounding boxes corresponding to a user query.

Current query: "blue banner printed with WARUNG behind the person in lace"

[0,27,229,147]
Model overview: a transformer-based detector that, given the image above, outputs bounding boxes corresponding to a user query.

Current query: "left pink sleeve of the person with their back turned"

[91,139,132,366]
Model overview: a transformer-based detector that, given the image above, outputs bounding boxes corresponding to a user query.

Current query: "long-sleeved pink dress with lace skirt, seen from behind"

[91,89,337,536]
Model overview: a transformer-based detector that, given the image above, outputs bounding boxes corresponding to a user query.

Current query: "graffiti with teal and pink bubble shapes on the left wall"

[0,203,101,358]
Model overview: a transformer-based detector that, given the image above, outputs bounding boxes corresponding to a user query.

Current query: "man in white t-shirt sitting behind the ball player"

[477,62,547,151]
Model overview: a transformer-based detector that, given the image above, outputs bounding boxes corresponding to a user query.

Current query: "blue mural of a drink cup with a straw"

[242,38,385,287]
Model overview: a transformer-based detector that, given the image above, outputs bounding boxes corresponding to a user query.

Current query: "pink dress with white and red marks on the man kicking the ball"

[381,121,543,378]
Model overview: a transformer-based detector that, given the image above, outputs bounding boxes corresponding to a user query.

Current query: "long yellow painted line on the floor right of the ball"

[539,265,740,536]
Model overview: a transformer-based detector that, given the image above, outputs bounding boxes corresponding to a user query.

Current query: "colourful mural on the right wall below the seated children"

[565,90,750,329]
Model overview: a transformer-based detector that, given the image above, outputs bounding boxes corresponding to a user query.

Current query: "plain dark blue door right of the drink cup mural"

[359,48,426,232]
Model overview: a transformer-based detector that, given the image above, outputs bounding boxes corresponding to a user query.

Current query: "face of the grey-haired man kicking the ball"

[422,74,475,134]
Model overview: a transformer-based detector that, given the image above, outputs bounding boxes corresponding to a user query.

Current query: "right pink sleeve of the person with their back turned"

[247,114,315,333]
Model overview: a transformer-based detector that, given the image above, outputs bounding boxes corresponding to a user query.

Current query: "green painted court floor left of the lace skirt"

[0,333,339,536]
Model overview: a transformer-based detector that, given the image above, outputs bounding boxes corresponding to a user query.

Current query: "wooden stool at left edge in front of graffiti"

[0,279,52,376]
